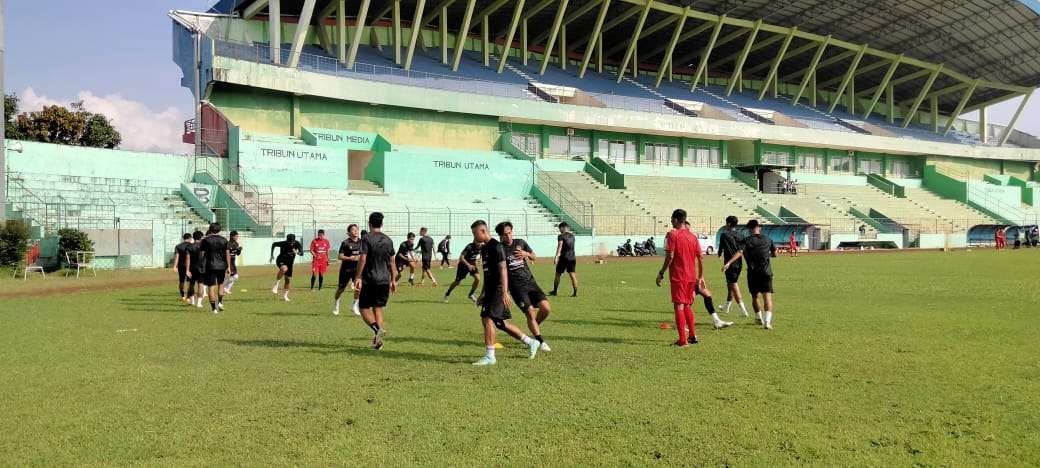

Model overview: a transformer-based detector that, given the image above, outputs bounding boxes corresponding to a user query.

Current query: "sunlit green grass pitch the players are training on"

[0,251,1040,466]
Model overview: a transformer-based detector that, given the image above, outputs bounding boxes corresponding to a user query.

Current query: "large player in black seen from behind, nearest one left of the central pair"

[354,211,397,350]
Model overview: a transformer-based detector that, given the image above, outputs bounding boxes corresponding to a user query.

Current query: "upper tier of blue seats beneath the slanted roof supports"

[216,41,996,145]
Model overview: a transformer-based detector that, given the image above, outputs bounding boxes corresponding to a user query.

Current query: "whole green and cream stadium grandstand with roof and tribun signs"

[6,0,1040,266]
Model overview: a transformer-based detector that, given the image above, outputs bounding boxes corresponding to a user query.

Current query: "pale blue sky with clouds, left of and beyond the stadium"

[4,0,1040,152]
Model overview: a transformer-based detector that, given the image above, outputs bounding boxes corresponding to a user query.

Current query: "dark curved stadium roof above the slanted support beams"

[211,0,1040,113]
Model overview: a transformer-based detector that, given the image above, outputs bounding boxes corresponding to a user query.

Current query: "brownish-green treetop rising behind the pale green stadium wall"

[4,95,123,148]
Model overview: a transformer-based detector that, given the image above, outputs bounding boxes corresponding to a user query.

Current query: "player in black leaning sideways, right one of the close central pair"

[495,222,552,352]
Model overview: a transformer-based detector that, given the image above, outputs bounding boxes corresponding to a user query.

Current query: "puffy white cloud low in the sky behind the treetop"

[19,87,191,153]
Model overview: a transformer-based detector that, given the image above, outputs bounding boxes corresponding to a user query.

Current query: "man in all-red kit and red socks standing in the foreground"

[656,209,704,347]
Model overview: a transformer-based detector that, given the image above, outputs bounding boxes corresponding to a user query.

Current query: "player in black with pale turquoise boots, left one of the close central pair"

[470,219,541,366]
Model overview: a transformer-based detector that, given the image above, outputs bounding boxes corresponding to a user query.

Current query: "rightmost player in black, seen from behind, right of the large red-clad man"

[722,219,777,330]
